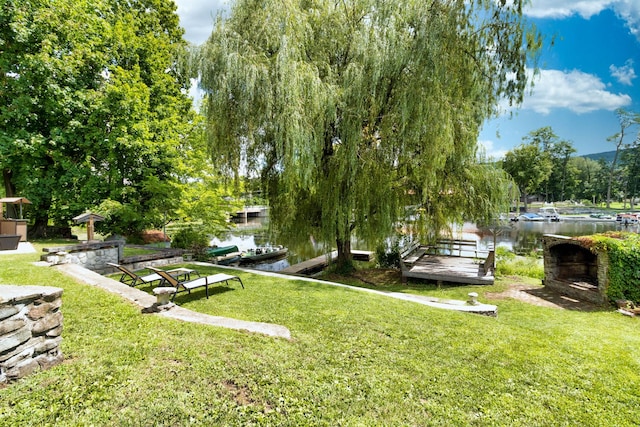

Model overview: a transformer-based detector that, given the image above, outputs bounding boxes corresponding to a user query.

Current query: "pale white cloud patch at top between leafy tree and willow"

[174,0,231,44]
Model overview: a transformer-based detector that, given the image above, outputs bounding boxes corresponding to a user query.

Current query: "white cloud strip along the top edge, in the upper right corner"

[525,0,640,40]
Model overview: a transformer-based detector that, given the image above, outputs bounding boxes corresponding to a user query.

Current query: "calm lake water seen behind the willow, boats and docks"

[211,218,639,271]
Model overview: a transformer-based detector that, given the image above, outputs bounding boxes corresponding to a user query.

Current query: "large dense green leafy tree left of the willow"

[0,0,200,241]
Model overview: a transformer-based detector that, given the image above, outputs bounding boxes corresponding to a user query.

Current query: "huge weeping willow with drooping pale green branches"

[200,0,540,267]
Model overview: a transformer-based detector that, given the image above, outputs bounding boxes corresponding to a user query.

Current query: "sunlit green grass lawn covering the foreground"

[0,246,640,426]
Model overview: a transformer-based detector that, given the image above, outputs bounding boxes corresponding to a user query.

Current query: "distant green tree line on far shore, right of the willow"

[502,109,640,210]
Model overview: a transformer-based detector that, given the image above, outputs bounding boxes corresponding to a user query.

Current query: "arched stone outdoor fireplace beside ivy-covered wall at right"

[542,234,609,305]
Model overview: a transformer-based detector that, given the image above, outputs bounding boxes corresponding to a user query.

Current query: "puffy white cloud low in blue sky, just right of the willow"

[521,70,631,115]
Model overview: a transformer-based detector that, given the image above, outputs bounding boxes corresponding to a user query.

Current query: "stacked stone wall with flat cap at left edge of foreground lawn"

[0,285,63,384]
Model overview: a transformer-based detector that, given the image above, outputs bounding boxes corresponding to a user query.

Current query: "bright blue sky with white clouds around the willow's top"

[175,0,640,158]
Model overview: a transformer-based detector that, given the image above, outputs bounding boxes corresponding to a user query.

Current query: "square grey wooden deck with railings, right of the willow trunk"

[401,242,495,285]
